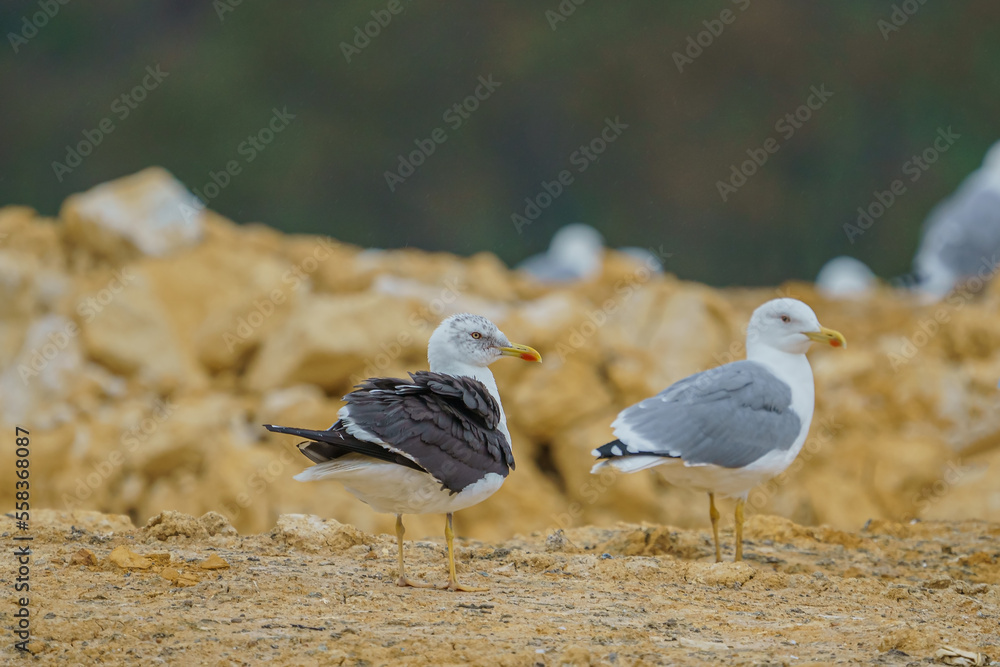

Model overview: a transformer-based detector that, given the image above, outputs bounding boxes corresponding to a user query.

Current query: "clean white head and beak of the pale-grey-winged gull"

[747,299,847,359]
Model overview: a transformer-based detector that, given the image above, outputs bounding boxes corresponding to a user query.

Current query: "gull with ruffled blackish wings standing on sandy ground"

[265,313,542,591]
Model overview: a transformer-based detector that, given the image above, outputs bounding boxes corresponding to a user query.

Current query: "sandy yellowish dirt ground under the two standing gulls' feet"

[0,511,1000,666]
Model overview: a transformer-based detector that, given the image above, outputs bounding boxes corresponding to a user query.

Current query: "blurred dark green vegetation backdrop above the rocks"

[0,0,1000,285]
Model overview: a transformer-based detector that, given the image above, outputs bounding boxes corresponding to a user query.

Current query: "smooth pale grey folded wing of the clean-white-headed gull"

[611,361,802,468]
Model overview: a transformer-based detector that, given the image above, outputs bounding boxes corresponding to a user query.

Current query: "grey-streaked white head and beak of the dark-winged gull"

[427,313,542,373]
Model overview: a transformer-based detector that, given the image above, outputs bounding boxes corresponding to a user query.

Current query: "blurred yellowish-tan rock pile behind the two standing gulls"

[0,170,1000,539]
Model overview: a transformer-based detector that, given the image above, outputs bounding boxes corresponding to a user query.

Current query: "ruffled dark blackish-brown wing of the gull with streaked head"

[341,371,514,493]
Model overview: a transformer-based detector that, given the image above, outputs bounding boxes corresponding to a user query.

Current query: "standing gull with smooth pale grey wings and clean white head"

[591,299,846,562]
